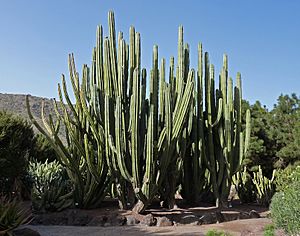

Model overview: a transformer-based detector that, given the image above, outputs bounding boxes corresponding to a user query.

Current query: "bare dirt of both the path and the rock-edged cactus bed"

[23,201,284,236]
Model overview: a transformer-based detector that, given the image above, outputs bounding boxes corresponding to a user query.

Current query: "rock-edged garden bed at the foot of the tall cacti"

[27,202,268,227]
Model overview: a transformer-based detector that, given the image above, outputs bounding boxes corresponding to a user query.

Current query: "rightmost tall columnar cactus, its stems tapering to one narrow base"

[203,53,250,206]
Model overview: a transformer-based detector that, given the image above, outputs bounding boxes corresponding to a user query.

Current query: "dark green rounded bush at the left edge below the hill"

[0,111,34,195]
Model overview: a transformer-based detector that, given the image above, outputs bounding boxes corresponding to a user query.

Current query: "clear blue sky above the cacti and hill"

[0,0,300,108]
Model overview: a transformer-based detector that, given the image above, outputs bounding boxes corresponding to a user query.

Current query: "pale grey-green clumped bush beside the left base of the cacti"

[29,161,72,211]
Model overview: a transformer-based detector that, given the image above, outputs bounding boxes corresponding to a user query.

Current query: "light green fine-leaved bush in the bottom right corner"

[270,181,300,235]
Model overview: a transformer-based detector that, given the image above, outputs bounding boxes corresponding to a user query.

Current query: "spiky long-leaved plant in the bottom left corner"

[0,196,31,235]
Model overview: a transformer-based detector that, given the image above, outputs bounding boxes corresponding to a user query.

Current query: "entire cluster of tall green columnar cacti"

[27,12,250,212]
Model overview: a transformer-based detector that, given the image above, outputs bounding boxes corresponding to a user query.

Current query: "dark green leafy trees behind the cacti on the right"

[242,94,300,177]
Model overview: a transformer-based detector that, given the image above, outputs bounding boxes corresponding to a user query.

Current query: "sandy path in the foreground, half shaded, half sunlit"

[23,218,271,236]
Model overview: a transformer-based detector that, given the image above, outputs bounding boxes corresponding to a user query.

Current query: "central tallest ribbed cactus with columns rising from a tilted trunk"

[92,12,194,212]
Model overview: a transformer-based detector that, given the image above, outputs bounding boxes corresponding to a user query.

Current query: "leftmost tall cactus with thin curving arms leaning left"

[26,55,111,208]
